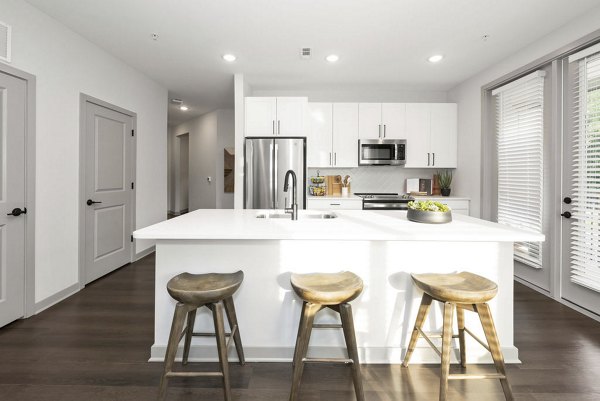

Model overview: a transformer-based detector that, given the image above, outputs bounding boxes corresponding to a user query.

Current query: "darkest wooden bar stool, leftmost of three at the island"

[158,271,245,401]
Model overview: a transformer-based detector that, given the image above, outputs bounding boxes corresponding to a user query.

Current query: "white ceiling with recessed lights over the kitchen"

[27,0,600,124]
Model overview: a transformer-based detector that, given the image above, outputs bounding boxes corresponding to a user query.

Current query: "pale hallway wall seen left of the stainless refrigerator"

[171,110,234,212]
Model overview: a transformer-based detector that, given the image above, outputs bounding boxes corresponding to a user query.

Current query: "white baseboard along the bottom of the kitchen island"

[149,344,521,364]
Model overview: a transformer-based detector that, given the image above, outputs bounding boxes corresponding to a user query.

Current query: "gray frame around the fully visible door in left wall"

[77,93,137,289]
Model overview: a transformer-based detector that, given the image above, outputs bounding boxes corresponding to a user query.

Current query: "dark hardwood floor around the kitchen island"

[0,256,600,401]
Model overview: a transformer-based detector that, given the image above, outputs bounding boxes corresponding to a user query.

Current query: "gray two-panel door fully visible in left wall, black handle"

[82,102,133,284]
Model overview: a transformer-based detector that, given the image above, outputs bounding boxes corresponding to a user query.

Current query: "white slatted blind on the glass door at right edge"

[570,52,600,292]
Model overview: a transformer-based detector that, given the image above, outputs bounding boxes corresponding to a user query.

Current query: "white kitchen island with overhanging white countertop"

[134,210,544,363]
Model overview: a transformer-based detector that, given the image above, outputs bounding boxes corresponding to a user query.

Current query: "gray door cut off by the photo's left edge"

[0,73,27,327]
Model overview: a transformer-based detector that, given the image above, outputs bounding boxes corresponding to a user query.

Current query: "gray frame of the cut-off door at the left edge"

[0,63,36,318]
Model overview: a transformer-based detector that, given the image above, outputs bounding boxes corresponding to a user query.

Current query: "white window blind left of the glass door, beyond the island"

[492,71,544,268]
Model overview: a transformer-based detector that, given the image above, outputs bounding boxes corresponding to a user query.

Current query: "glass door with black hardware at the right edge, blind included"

[561,45,600,315]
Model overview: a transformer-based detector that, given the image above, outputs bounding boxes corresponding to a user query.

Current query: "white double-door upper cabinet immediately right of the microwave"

[405,103,458,168]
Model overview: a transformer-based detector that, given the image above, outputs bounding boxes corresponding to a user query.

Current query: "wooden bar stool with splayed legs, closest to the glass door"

[402,272,513,401]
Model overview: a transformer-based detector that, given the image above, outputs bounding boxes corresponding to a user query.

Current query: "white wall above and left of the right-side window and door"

[448,7,600,216]
